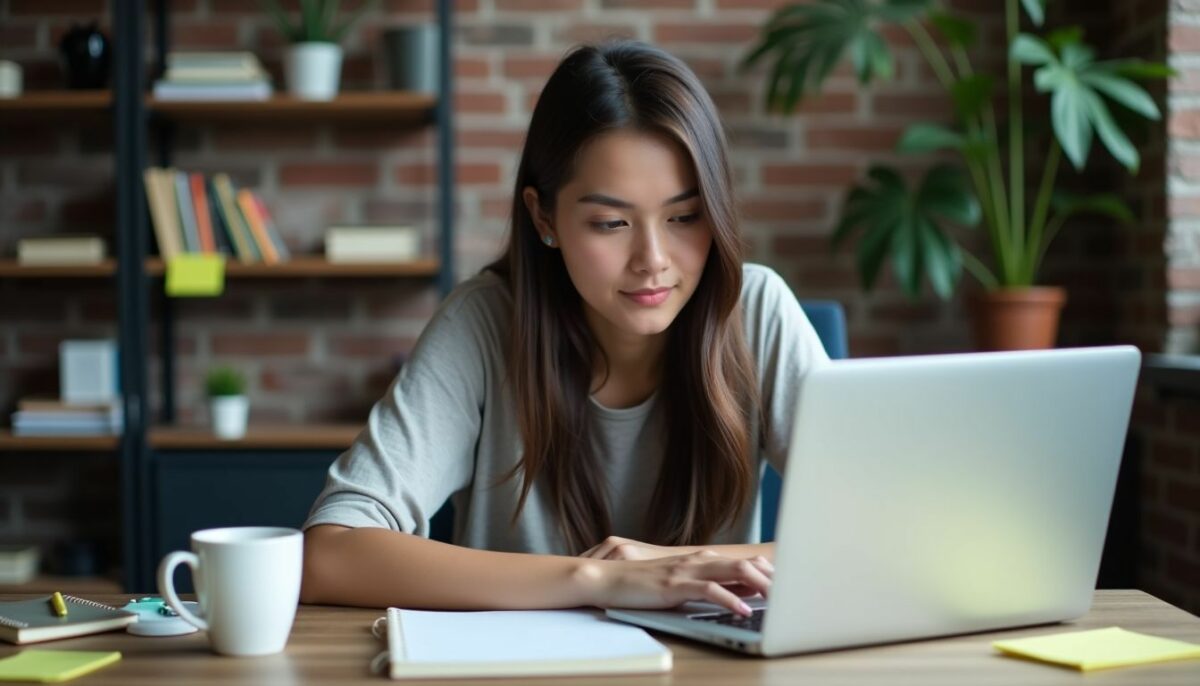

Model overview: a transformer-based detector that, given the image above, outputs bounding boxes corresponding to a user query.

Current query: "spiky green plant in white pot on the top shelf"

[265,0,376,100]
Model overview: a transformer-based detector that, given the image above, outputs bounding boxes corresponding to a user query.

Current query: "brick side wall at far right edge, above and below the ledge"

[1118,0,1200,613]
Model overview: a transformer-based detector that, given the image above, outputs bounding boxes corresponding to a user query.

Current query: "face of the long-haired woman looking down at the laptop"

[526,131,713,342]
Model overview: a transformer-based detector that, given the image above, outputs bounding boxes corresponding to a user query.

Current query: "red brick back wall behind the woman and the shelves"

[0,0,1200,604]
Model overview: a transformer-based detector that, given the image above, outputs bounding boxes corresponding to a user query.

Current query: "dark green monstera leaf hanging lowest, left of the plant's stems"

[833,164,980,300]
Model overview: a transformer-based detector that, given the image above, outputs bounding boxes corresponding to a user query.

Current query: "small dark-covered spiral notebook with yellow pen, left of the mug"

[0,595,138,645]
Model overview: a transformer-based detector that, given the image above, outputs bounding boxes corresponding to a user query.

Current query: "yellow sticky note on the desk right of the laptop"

[991,626,1200,672]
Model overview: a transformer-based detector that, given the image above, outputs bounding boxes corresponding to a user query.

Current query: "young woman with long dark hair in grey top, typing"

[301,42,828,614]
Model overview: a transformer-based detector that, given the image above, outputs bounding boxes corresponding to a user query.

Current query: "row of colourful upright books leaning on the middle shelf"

[143,167,292,264]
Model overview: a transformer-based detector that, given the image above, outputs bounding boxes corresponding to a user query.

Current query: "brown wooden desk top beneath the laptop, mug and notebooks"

[0,590,1200,686]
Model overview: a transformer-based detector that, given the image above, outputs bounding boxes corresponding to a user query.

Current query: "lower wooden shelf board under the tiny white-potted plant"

[146,425,362,450]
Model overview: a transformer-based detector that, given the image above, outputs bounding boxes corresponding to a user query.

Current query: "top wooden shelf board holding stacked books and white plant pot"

[146,91,437,125]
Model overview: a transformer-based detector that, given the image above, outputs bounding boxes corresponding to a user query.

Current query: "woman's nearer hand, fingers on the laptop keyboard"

[581,550,775,615]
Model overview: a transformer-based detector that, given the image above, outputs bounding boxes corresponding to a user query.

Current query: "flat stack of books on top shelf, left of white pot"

[154,52,272,101]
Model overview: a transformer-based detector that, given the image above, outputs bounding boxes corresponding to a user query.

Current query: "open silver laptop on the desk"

[608,347,1141,656]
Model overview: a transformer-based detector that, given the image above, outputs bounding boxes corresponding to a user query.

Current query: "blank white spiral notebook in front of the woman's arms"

[380,608,671,679]
